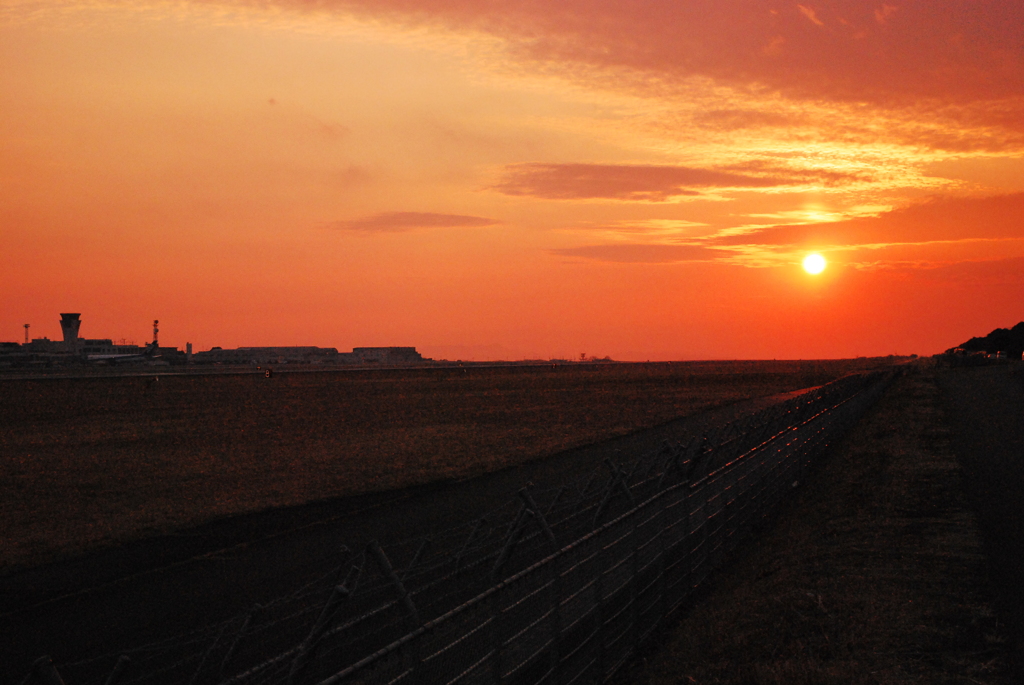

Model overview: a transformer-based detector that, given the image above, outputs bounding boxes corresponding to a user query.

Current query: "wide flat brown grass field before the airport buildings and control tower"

[0,359,893,572]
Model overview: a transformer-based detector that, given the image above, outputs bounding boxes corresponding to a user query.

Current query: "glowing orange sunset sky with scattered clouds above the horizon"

[0,0,1024,360]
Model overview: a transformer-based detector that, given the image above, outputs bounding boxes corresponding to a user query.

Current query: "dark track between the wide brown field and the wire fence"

[0,393,799,685]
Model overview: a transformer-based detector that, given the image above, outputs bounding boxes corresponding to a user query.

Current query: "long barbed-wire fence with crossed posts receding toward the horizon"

[36,372,893,685]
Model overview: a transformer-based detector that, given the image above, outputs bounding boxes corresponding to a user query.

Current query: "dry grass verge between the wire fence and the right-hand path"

[623,360,1010,685]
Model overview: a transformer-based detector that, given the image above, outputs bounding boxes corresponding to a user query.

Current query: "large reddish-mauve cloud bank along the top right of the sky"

[294,0,1024,108]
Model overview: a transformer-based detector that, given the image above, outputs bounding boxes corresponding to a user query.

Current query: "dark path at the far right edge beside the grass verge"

[939,365,1024,682]
